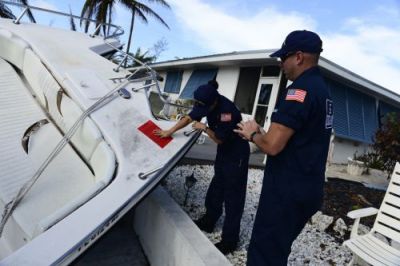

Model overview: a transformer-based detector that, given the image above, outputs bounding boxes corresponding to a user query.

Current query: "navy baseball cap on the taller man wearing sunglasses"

[270,30,322,57]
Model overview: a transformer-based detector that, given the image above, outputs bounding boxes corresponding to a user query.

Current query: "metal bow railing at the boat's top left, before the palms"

[0,0,124,39]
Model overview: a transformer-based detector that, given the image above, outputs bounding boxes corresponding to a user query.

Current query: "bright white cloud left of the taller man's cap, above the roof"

[170,0,315,52]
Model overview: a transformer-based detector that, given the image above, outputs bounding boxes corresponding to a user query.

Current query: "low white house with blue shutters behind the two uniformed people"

[152,50,400,163]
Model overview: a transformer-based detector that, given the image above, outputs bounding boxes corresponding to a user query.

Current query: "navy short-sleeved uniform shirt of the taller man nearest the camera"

[265,67,333,194]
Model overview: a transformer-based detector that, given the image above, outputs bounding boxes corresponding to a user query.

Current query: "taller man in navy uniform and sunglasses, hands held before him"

[235,30,333,266]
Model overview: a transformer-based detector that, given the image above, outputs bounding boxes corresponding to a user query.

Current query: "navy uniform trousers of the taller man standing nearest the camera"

[247,177,322,266]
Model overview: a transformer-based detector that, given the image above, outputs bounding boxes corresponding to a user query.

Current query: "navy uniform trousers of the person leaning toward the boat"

[205,157,248,243]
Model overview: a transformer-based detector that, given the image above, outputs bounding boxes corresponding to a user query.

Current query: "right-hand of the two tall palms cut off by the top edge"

[81,0,170,53]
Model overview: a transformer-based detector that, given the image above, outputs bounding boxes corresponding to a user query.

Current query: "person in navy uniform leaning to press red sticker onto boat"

[156,81,250,254]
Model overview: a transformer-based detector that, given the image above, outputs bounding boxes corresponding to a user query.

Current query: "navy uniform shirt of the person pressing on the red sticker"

[189,95,250,161]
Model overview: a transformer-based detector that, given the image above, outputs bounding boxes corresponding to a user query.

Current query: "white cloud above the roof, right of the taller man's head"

[323,21,400,94]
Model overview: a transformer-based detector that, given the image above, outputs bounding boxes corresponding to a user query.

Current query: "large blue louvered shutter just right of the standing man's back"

[327,80,378,143]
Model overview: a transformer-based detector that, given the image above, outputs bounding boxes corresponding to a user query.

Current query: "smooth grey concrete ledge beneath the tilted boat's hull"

[134,187,231,266]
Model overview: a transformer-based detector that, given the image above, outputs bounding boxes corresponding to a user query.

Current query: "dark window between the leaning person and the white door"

[234,67,261,114]
